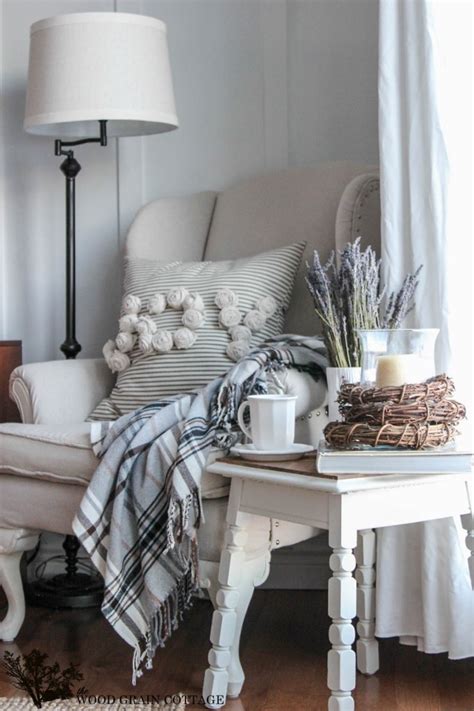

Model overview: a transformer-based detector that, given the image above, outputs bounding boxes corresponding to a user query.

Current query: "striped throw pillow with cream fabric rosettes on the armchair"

[88,242,305,420]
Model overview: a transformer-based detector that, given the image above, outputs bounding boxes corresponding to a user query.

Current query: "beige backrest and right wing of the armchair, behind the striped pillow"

[204,162,380,335]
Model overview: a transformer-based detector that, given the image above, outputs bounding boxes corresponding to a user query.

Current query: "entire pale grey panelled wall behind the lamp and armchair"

[0,0,377,362]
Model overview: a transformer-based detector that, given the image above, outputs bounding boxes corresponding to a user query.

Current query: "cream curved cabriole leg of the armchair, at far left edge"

[0,528,38,642]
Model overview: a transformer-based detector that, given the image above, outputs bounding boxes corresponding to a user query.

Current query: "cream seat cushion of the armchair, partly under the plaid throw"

[0,422,229,498]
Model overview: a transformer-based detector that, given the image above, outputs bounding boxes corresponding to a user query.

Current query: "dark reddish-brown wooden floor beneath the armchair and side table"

[0,590,474,711]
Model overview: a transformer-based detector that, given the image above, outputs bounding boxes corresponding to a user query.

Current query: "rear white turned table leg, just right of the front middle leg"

[355,529,379,674]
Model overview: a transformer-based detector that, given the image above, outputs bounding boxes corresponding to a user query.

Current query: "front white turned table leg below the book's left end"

[327,497,357,711]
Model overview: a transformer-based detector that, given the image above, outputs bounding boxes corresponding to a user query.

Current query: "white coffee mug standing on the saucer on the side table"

[237,395,297,451]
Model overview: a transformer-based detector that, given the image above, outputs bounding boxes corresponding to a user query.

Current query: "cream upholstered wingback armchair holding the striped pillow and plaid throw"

[0,163,380,696]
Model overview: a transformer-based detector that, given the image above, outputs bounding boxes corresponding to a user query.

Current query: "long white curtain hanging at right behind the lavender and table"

[377,0,474,658]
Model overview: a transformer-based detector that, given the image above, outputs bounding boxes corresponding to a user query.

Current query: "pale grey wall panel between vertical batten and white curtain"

[287,0,378,165]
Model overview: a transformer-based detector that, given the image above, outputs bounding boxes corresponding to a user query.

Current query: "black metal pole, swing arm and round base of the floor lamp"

[28,121,107,607]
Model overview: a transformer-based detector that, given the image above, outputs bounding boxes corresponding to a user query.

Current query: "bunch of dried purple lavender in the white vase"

[306,237,421,368]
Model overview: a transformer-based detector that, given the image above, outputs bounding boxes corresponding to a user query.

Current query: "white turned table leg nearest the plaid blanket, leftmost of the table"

[203,479,247,709]
